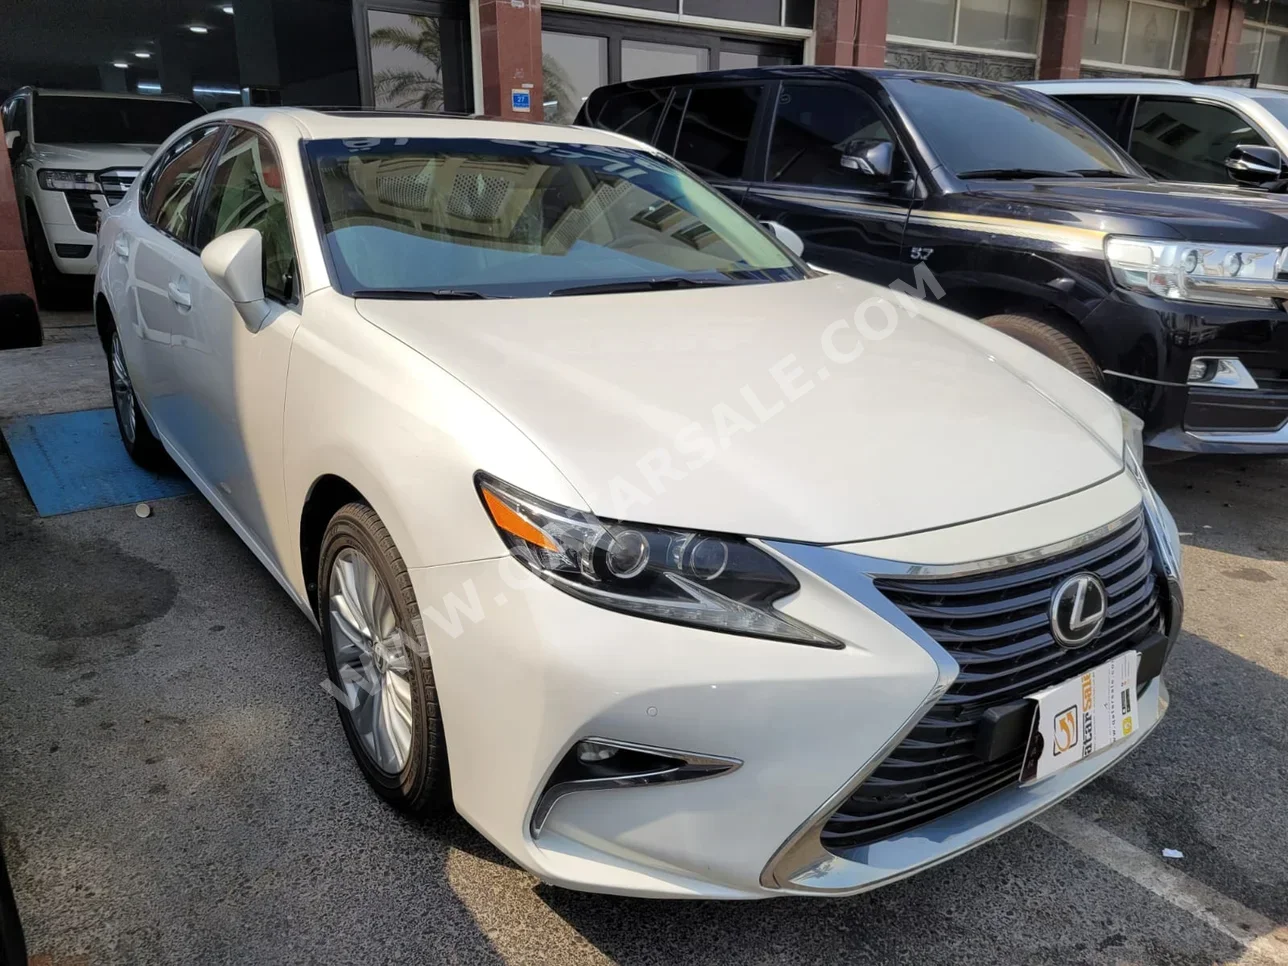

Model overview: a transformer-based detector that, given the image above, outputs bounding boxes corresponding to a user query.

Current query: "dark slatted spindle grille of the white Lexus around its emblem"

[820,515,1163,851]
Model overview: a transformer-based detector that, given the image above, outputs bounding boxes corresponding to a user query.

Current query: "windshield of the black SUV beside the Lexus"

[889,77,1141,178]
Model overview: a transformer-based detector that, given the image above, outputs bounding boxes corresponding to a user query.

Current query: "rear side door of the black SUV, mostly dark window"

[657,84,770,204]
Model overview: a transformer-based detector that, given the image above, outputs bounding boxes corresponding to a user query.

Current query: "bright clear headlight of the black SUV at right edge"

[1105,238,1288,309]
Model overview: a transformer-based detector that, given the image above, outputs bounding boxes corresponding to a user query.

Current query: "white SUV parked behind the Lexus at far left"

[0,88,204,298]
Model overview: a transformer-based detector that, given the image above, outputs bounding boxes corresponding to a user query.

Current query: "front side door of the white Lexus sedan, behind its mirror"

[170,125,300,567]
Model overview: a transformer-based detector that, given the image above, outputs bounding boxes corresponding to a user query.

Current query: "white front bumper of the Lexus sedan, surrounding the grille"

[411,474,1166,899]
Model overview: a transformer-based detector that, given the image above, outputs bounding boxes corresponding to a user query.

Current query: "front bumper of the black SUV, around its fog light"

[1083,292,1288,455]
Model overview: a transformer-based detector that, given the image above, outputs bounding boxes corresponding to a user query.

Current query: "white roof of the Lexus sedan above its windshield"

[208,107,654,153]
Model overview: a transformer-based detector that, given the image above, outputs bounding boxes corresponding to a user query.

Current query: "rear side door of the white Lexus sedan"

[123,124,223,422]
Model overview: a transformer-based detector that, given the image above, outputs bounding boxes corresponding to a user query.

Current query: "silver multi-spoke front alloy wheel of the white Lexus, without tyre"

[327,547,412,775]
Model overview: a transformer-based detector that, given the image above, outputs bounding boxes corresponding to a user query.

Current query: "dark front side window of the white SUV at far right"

[1131,97,1266,183]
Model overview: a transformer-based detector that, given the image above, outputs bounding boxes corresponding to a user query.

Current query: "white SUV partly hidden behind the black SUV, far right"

[1023,77,1288,185]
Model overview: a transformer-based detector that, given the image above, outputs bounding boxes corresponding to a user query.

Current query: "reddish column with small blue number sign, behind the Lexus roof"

[474,0,544,121]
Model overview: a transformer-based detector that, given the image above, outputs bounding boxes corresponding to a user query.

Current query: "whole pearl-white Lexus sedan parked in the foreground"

[95,108,1181,899]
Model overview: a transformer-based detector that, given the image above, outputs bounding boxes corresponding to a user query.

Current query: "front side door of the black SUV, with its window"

[742,81,913,285]
